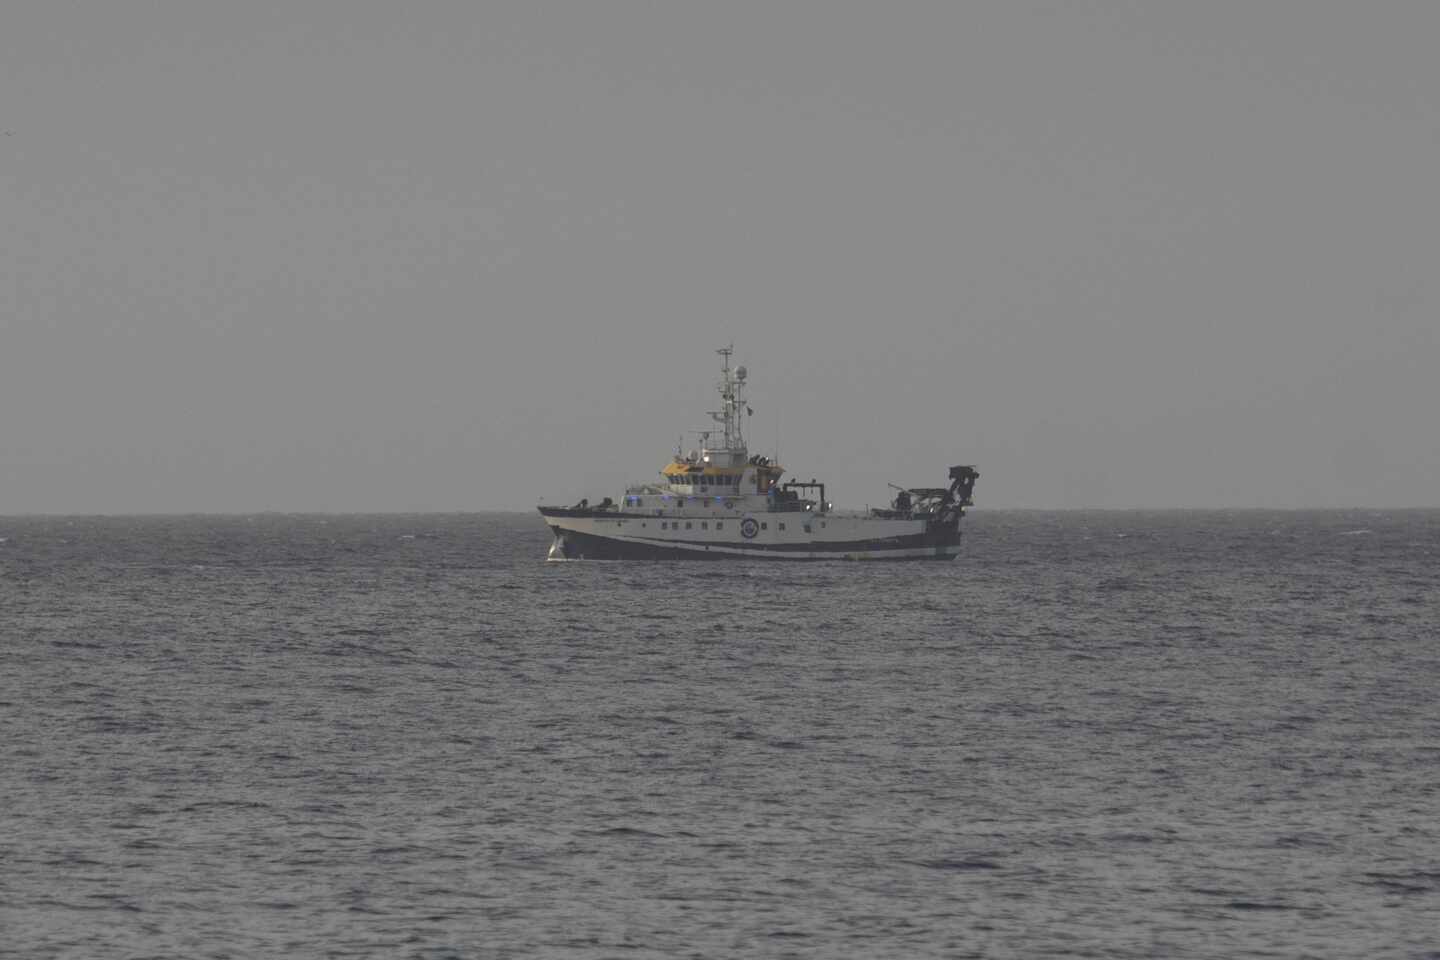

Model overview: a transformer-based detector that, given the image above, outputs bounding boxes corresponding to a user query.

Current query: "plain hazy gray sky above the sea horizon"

[0,0,1440,514]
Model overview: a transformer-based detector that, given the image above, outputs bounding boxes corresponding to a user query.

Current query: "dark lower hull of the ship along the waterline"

[549,527,960,561]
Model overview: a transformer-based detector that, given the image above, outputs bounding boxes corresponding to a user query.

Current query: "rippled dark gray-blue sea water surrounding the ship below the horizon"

[0,510,1440,959]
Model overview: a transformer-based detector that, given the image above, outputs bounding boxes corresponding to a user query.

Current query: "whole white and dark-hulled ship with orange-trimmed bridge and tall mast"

[539,347,979,560]
